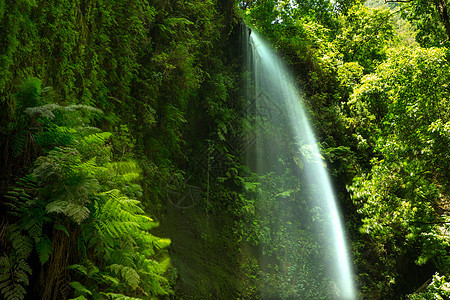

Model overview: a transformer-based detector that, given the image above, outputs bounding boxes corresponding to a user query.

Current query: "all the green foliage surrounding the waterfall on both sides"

[0,0,450,299]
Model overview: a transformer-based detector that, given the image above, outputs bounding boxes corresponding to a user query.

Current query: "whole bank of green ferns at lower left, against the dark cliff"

[0,79,170,300]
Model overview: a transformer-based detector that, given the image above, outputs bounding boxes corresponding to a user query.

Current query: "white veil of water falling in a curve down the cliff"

[245,29,357,299]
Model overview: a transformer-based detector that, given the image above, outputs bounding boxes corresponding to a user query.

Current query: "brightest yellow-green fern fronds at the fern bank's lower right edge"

[84,184,170,295]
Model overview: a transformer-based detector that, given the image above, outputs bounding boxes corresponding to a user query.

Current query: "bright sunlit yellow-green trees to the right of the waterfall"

[245,1,450,299]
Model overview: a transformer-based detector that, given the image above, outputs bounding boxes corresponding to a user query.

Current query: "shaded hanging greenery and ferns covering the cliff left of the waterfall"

[0,0,241,299]
